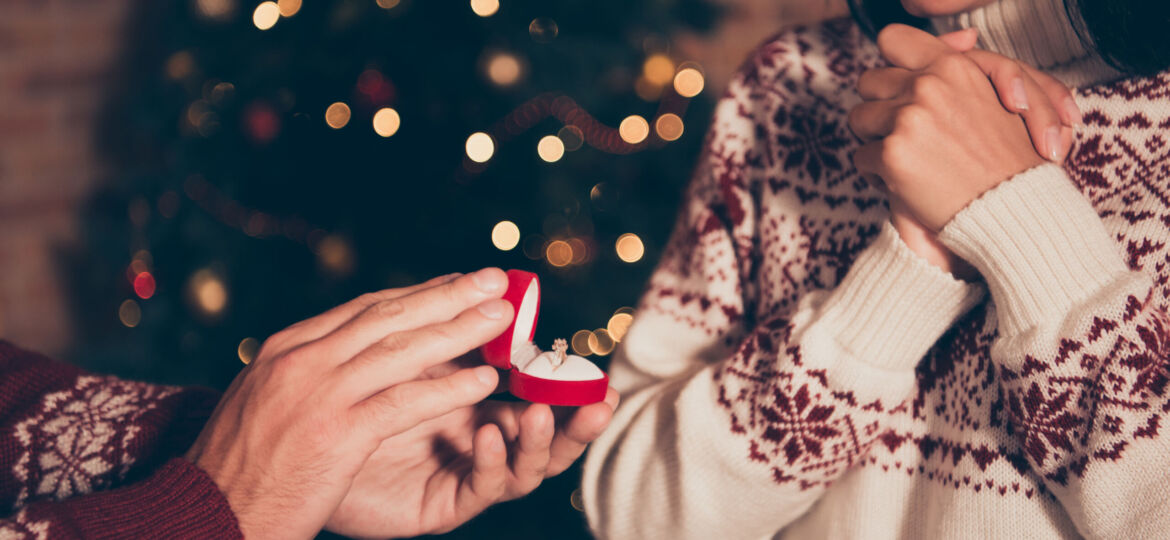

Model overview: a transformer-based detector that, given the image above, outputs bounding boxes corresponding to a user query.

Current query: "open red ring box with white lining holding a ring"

[480,270,610,407]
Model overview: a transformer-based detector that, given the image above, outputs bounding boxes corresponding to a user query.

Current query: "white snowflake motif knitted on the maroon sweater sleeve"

[13,376,177,508]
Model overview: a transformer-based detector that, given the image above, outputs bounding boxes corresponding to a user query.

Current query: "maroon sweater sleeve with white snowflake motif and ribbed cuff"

[0,341,241,539]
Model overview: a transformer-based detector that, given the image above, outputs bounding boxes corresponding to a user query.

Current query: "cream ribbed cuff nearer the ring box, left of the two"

[819,223,983,369]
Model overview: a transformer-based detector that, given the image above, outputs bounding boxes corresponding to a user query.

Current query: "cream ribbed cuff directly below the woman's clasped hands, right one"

[938,164,1128,335]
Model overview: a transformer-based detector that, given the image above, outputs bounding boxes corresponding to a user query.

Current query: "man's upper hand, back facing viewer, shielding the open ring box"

[186,269,514,539]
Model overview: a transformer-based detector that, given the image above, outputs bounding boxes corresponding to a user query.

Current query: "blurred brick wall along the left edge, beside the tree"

[0,0,131,353]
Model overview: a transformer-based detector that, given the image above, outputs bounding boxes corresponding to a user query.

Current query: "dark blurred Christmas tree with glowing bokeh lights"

[70,0,715,538]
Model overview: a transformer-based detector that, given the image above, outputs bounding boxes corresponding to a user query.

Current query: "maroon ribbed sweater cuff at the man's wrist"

[60,458,243,539]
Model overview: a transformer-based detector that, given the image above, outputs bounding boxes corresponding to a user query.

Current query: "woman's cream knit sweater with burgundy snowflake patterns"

[583,0,1170,539]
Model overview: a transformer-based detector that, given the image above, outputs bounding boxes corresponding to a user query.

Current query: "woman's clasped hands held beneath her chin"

[849,25,1074,231]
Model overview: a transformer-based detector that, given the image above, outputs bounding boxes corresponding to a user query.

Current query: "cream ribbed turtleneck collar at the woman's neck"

[930,0,1122,88]
